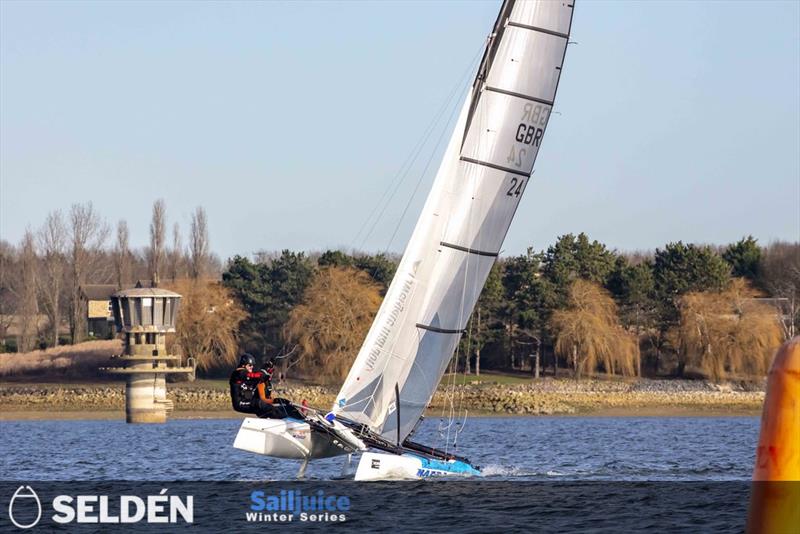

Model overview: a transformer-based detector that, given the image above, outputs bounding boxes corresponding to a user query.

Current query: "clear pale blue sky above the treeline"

[0,0,800,259]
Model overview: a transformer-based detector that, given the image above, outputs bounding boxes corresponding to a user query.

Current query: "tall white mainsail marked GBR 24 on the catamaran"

[333,0,574,440]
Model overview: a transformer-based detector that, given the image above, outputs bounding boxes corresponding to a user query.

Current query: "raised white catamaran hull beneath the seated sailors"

[233,417,366,460]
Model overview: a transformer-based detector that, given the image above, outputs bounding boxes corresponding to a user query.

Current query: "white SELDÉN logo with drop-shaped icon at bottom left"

[8,485,194,529]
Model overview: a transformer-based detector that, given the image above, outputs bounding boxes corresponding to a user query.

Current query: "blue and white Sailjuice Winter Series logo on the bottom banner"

[245,490,350,523]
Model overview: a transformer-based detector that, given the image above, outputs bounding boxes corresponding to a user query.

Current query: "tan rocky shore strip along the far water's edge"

[0,379,764,420]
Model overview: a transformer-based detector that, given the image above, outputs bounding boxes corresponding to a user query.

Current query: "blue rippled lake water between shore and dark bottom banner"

[0,417,759,481]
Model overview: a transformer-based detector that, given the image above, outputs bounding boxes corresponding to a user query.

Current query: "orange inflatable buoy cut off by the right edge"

[747,336,800,534]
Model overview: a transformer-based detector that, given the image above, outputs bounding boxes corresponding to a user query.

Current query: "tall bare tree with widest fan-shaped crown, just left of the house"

[69,202,108,343]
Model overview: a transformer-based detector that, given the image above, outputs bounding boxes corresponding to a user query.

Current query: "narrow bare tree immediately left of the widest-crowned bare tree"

[38,210,67,347]
